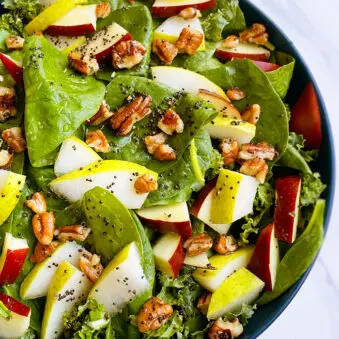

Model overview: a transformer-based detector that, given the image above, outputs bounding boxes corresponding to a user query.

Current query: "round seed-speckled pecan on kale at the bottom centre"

[137,297,173,333]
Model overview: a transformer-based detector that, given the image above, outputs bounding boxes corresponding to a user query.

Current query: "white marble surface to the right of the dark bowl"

[247,0,339,339]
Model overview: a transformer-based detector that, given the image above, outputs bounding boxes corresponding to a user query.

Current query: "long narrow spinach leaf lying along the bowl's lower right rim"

[257,200,326,305]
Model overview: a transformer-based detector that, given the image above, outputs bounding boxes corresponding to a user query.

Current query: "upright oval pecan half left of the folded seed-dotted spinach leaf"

[32,212,55,245]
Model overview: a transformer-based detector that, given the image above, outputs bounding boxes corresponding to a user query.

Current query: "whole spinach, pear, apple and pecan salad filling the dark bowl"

[0,0,326,339]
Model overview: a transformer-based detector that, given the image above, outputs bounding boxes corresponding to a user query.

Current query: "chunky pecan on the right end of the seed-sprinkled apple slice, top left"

[112,40,146,69]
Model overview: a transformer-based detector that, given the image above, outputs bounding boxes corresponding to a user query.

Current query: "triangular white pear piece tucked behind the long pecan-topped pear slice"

[54,136,101,177]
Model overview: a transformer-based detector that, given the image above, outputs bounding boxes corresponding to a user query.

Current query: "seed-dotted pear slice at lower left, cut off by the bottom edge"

[41,261,92,339]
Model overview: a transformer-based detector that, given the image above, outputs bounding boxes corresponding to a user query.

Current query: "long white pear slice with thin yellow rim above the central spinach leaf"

[151,66,227,100]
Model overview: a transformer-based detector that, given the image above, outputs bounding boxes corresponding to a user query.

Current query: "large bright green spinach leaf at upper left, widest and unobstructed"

[23,36,105,167]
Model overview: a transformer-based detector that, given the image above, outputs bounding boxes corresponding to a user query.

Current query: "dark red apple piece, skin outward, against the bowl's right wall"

[290,82,322,149]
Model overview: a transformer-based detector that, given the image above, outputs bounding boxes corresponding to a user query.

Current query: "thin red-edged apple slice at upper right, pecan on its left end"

[215,41,271,61]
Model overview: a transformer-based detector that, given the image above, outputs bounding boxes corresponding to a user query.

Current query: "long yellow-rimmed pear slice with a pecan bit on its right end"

[50,160,158,209]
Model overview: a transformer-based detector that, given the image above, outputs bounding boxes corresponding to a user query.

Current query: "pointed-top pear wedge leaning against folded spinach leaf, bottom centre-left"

[89,242,149,315]
